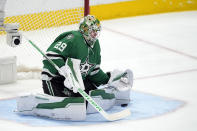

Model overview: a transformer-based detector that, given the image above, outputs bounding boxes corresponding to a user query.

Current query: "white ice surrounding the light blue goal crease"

[0,11,197,131]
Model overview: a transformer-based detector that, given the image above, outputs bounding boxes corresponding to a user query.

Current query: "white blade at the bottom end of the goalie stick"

[105,109,131,121]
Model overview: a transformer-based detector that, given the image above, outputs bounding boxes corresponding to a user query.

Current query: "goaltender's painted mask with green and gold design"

[79,15,101,47]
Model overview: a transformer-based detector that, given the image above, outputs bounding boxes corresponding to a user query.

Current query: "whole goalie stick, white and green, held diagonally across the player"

[23,35,131,121]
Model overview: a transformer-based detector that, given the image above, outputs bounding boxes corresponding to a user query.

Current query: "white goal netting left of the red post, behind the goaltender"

[0,0,88,79]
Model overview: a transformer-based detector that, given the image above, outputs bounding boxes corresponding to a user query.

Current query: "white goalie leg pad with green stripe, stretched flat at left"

[17,94,86,121]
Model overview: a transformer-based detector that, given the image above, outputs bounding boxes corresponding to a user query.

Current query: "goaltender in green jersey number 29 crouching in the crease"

[17,15,133,121]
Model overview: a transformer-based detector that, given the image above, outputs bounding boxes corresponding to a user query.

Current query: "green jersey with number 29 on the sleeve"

[42,31,109,86]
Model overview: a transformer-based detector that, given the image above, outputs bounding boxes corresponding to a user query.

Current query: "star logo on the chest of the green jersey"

[80,57,95,75]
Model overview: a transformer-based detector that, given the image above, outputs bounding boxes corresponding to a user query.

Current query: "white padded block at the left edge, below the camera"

[0,56,17,84]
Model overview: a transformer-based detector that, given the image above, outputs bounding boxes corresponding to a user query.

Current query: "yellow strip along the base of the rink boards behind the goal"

[0,0,197,35]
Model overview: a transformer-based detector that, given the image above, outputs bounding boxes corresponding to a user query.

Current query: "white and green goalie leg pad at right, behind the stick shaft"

[87,89,115,113]
